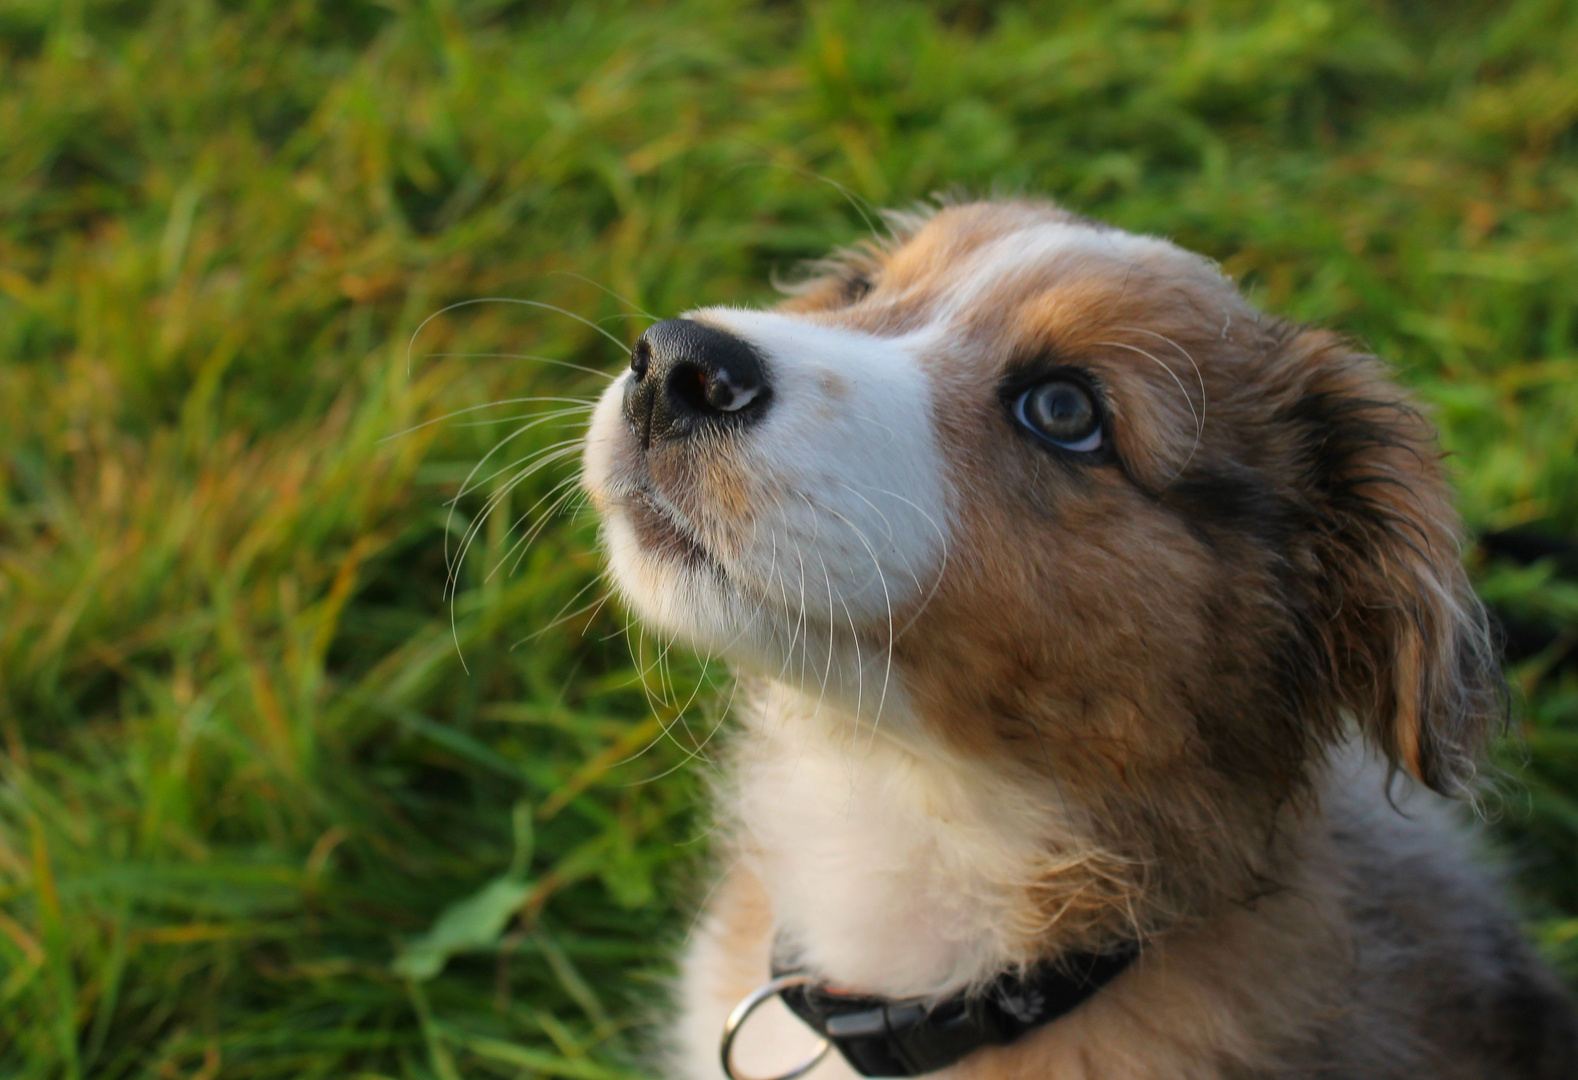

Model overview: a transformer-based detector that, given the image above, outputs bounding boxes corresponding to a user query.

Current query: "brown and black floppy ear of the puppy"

[1280,332,1505,794]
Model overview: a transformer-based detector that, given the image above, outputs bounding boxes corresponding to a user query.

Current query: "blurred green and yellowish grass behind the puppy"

[0,0,1578,1080]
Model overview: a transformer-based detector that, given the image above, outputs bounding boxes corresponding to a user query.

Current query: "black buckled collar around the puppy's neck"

[773,946,1139,1077]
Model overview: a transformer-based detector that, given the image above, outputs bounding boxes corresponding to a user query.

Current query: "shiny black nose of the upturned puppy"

[625,319,770,447]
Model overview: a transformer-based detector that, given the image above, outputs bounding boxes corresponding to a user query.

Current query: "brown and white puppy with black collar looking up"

[585,201,1578,1080]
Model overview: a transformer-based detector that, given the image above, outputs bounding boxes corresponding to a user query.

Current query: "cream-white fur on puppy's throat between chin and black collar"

[732,684,1071,996]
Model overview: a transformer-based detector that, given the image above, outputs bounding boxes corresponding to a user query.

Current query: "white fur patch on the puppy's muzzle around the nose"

[585,308,952,715]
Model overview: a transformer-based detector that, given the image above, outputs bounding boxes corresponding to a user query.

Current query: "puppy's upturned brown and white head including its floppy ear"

[585,195,1498,928]
